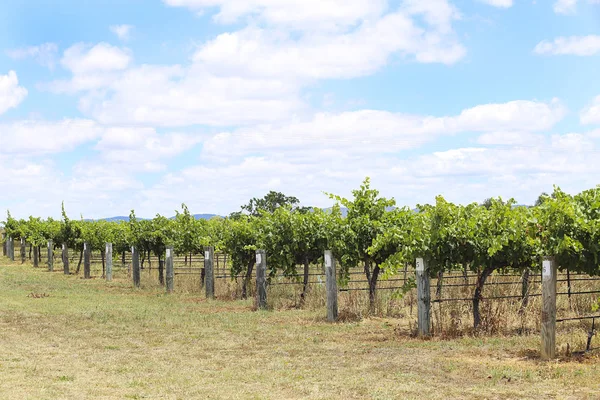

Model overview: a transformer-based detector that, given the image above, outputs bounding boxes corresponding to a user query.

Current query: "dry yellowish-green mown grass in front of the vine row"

[0,258,600,399]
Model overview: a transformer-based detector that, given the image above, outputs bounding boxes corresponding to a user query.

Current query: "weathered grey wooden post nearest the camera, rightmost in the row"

[542,257,556,360]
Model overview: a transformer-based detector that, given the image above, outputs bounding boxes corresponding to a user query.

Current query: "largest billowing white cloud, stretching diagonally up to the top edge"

[51,0,465,126]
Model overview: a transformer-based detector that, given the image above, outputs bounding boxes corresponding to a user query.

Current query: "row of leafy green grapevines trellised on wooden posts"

[3,179,600,358]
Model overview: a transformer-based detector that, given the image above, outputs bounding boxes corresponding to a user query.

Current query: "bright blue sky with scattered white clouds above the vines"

[0,0,600,219]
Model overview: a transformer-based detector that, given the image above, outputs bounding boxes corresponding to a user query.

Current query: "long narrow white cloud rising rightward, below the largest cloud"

[203,100,565,161]
